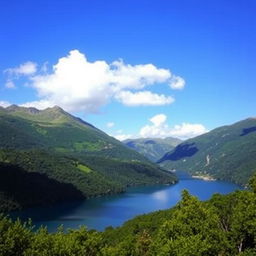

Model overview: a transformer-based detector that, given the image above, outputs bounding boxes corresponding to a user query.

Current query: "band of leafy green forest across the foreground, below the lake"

[0,175,256,256]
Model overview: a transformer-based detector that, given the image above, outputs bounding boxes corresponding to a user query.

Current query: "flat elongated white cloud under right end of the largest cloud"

[116,91,174,106]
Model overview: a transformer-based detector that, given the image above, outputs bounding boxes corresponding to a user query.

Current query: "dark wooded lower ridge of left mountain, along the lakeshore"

[0,149,176,212]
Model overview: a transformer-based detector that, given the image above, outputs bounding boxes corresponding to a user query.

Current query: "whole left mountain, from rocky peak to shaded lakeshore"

[0,105,176,211]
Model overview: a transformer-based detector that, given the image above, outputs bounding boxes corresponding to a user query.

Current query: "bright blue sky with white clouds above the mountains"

[0,0,256,140]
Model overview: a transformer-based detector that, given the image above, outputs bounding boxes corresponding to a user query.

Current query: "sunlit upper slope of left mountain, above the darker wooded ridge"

[0,105,146,161]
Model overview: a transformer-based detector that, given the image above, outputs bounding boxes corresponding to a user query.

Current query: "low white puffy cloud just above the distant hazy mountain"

[139,114,207,140]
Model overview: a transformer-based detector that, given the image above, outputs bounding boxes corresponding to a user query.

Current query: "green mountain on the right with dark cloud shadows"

[158,118,256,185]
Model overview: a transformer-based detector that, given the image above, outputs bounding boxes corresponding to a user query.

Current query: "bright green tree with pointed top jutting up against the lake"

[152,191,226,256]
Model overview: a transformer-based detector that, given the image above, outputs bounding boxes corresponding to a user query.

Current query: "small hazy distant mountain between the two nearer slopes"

[123,137,182,162]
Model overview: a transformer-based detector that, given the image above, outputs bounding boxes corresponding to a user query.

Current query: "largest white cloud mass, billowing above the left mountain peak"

[6,50,184,113]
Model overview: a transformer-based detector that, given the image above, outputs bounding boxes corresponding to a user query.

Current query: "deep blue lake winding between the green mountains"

[12,174,242,232]
